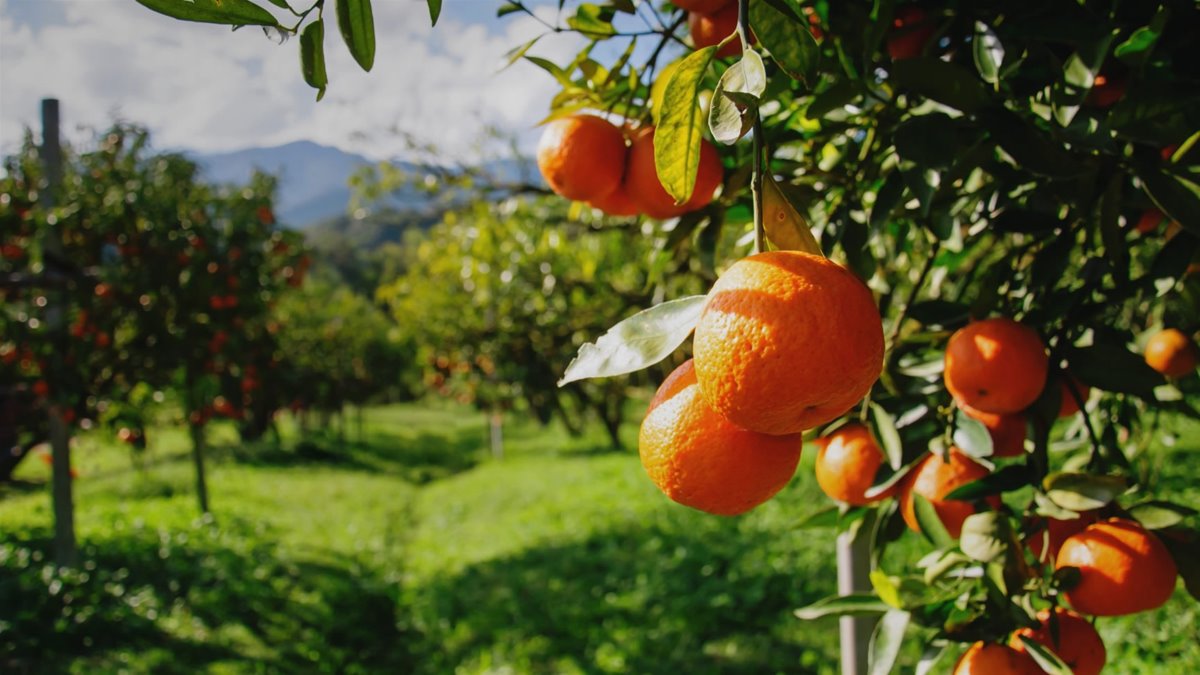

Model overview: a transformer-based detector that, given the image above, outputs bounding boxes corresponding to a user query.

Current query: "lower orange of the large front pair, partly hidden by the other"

[637,360,802,515]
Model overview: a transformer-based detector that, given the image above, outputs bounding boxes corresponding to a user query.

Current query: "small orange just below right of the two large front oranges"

[816,424,888,506]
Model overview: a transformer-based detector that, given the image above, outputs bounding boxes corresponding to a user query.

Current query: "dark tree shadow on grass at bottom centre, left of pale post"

[404,521,836,674]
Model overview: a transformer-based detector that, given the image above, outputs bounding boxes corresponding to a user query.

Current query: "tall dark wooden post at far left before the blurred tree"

[41,98,78,567]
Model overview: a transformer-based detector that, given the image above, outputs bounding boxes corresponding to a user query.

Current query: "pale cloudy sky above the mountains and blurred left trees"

[0,0,600,160]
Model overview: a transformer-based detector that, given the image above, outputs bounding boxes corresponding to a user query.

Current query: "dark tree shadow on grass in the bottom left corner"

[0,522,412,673]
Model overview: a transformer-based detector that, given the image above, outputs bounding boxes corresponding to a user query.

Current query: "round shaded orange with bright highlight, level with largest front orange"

[943,317,1050,414]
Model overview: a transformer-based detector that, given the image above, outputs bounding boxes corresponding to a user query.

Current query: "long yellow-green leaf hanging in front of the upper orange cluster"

[654,47,716,204]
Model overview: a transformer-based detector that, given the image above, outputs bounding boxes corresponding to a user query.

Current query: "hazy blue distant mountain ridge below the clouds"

[191,141,540,229]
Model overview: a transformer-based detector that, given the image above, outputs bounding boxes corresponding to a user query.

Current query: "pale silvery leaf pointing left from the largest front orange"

[558,295,707,387]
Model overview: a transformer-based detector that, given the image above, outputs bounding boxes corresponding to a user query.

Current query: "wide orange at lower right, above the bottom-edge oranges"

[1055,518,1178,616]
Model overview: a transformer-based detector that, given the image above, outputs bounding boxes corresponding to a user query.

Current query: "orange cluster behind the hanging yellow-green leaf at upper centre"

[538,114,725,219]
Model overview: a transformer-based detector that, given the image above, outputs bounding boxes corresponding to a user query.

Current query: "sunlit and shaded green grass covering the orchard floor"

[0,406,1200,674]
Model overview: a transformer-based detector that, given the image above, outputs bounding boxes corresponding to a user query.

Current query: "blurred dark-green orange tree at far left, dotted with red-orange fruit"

[0,125,304,509]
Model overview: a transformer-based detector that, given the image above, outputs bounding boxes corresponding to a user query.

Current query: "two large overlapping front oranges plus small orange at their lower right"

[638,251,883,515]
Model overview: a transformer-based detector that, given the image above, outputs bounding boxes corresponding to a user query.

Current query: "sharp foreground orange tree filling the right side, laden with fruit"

[131,0,1200,673]
